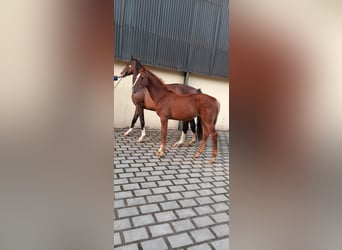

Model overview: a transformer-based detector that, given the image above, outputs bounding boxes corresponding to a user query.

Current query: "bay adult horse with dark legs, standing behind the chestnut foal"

[120,56,202,147]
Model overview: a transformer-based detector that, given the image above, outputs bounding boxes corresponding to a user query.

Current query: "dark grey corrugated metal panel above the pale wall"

[114,0,228,78]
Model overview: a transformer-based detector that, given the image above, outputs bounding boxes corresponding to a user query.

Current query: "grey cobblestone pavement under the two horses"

[114,129,229,250]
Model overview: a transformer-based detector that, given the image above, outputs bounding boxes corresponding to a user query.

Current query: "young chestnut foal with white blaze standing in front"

[132,69,220,163]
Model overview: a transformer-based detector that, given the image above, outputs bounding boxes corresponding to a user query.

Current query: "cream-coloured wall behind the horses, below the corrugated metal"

[114,61,229,130]
